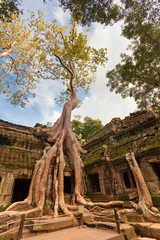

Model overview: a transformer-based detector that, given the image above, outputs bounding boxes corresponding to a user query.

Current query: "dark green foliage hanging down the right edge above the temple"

[107,0,160,109]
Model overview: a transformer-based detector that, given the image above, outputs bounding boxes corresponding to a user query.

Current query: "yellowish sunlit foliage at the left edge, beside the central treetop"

[0,15,41,107]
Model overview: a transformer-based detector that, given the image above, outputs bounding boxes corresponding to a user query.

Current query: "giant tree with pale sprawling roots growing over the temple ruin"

[0,12,110,216]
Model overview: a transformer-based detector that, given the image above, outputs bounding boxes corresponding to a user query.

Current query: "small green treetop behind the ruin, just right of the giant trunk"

[71,117,103,142]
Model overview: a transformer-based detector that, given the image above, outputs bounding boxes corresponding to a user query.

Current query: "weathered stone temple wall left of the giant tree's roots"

[0,120,43,209]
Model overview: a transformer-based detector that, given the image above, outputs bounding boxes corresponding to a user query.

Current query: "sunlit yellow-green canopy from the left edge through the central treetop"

[0,11,107,106]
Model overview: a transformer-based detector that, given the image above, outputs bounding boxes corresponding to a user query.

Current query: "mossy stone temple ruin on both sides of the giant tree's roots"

[0,111,160,210]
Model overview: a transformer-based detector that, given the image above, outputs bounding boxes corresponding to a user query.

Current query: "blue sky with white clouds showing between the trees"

[0,0,137,127]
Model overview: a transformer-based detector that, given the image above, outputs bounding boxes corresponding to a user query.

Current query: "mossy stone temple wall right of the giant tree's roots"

[83,111,160,204]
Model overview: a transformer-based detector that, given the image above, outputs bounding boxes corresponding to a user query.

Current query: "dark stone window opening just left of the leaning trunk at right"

[122,170,136,191]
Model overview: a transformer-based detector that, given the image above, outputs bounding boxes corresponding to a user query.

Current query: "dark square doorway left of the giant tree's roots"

[11,179,31,203]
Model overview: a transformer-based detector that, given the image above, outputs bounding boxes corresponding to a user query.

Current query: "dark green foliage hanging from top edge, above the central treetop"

[59,0,122,25]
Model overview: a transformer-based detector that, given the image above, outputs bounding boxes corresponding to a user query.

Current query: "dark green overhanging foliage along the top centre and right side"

[59,0,160,108]
